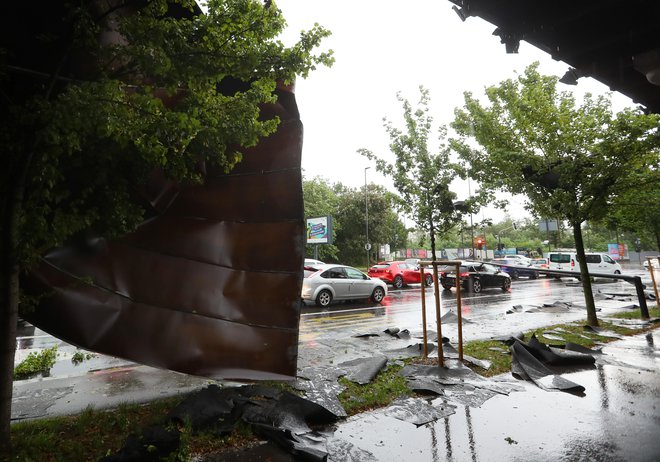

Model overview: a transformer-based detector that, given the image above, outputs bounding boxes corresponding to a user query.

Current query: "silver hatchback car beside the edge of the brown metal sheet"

[301,264,387,308]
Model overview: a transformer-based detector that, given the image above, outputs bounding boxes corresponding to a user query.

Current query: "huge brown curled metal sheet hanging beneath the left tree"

[27,88,304,379]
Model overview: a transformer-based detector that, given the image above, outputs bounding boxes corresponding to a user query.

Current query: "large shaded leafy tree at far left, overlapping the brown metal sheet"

[0,0,332,450]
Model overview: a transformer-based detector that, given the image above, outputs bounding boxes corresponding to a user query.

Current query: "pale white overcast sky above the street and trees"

[276,0,632,218]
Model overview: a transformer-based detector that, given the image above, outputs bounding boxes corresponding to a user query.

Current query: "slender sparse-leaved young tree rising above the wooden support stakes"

[358,87,462,260]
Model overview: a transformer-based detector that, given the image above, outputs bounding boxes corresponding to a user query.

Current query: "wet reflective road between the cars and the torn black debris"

[300,272,644,343]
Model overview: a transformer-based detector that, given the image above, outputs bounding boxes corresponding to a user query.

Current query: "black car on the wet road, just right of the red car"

[440,261,511,293]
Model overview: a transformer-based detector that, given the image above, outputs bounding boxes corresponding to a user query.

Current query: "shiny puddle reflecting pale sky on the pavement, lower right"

[329,365,660,462]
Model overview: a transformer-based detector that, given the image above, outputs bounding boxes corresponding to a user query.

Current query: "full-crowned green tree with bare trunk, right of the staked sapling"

[452,64,660,326]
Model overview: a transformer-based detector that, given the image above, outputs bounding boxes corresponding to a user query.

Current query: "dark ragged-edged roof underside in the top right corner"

[449,0,660,113]
